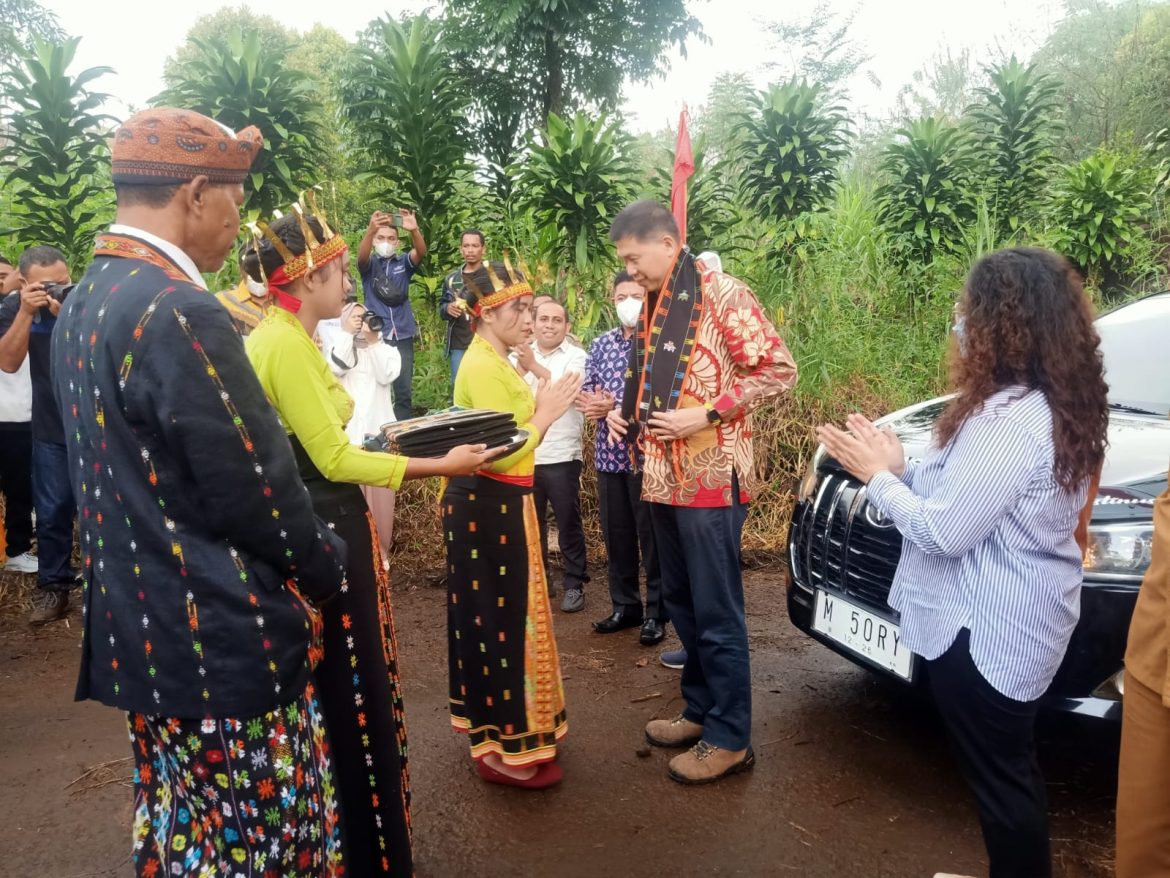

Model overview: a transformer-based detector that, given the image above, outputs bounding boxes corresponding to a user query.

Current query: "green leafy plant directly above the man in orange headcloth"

[152,30,323,217]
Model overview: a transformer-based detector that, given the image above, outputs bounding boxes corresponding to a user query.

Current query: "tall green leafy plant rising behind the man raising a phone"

[339,15,469,265]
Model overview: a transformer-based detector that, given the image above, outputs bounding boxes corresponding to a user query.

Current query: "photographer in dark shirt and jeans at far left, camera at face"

[0,246,77,625]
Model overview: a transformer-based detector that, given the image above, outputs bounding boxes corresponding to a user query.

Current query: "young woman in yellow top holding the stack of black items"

[246,214,490,877]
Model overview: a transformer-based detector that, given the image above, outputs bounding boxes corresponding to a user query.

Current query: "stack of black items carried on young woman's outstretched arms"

[381,407,528,458]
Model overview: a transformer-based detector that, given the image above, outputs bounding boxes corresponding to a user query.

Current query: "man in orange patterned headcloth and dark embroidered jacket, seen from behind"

[53,108,345,878]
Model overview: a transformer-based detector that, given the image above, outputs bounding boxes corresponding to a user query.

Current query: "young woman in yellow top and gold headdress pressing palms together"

[442,262,581,789]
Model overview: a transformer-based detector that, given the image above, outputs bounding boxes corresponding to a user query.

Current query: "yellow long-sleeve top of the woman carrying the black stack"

[245,307,407,488]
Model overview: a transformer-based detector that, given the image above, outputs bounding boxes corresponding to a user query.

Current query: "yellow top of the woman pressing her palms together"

[455,335,541,480]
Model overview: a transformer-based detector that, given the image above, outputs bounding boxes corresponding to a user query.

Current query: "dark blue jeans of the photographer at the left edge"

[33,439,77,591]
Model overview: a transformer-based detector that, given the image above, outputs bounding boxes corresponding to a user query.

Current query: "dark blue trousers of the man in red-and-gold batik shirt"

[649,485,751,750]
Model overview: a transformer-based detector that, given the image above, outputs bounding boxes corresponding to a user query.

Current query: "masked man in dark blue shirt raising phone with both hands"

[358,211,427,420]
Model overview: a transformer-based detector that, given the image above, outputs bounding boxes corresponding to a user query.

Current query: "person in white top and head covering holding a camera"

[317,300,402,562]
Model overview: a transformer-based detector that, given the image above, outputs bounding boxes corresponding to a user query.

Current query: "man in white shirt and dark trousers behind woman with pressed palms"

[515,299,589,612]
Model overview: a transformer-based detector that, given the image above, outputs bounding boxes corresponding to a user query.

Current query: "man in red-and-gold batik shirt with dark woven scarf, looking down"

[607,201,797,783]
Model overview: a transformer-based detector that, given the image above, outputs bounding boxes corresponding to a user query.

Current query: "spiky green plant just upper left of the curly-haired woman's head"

[878,117,976,265]
